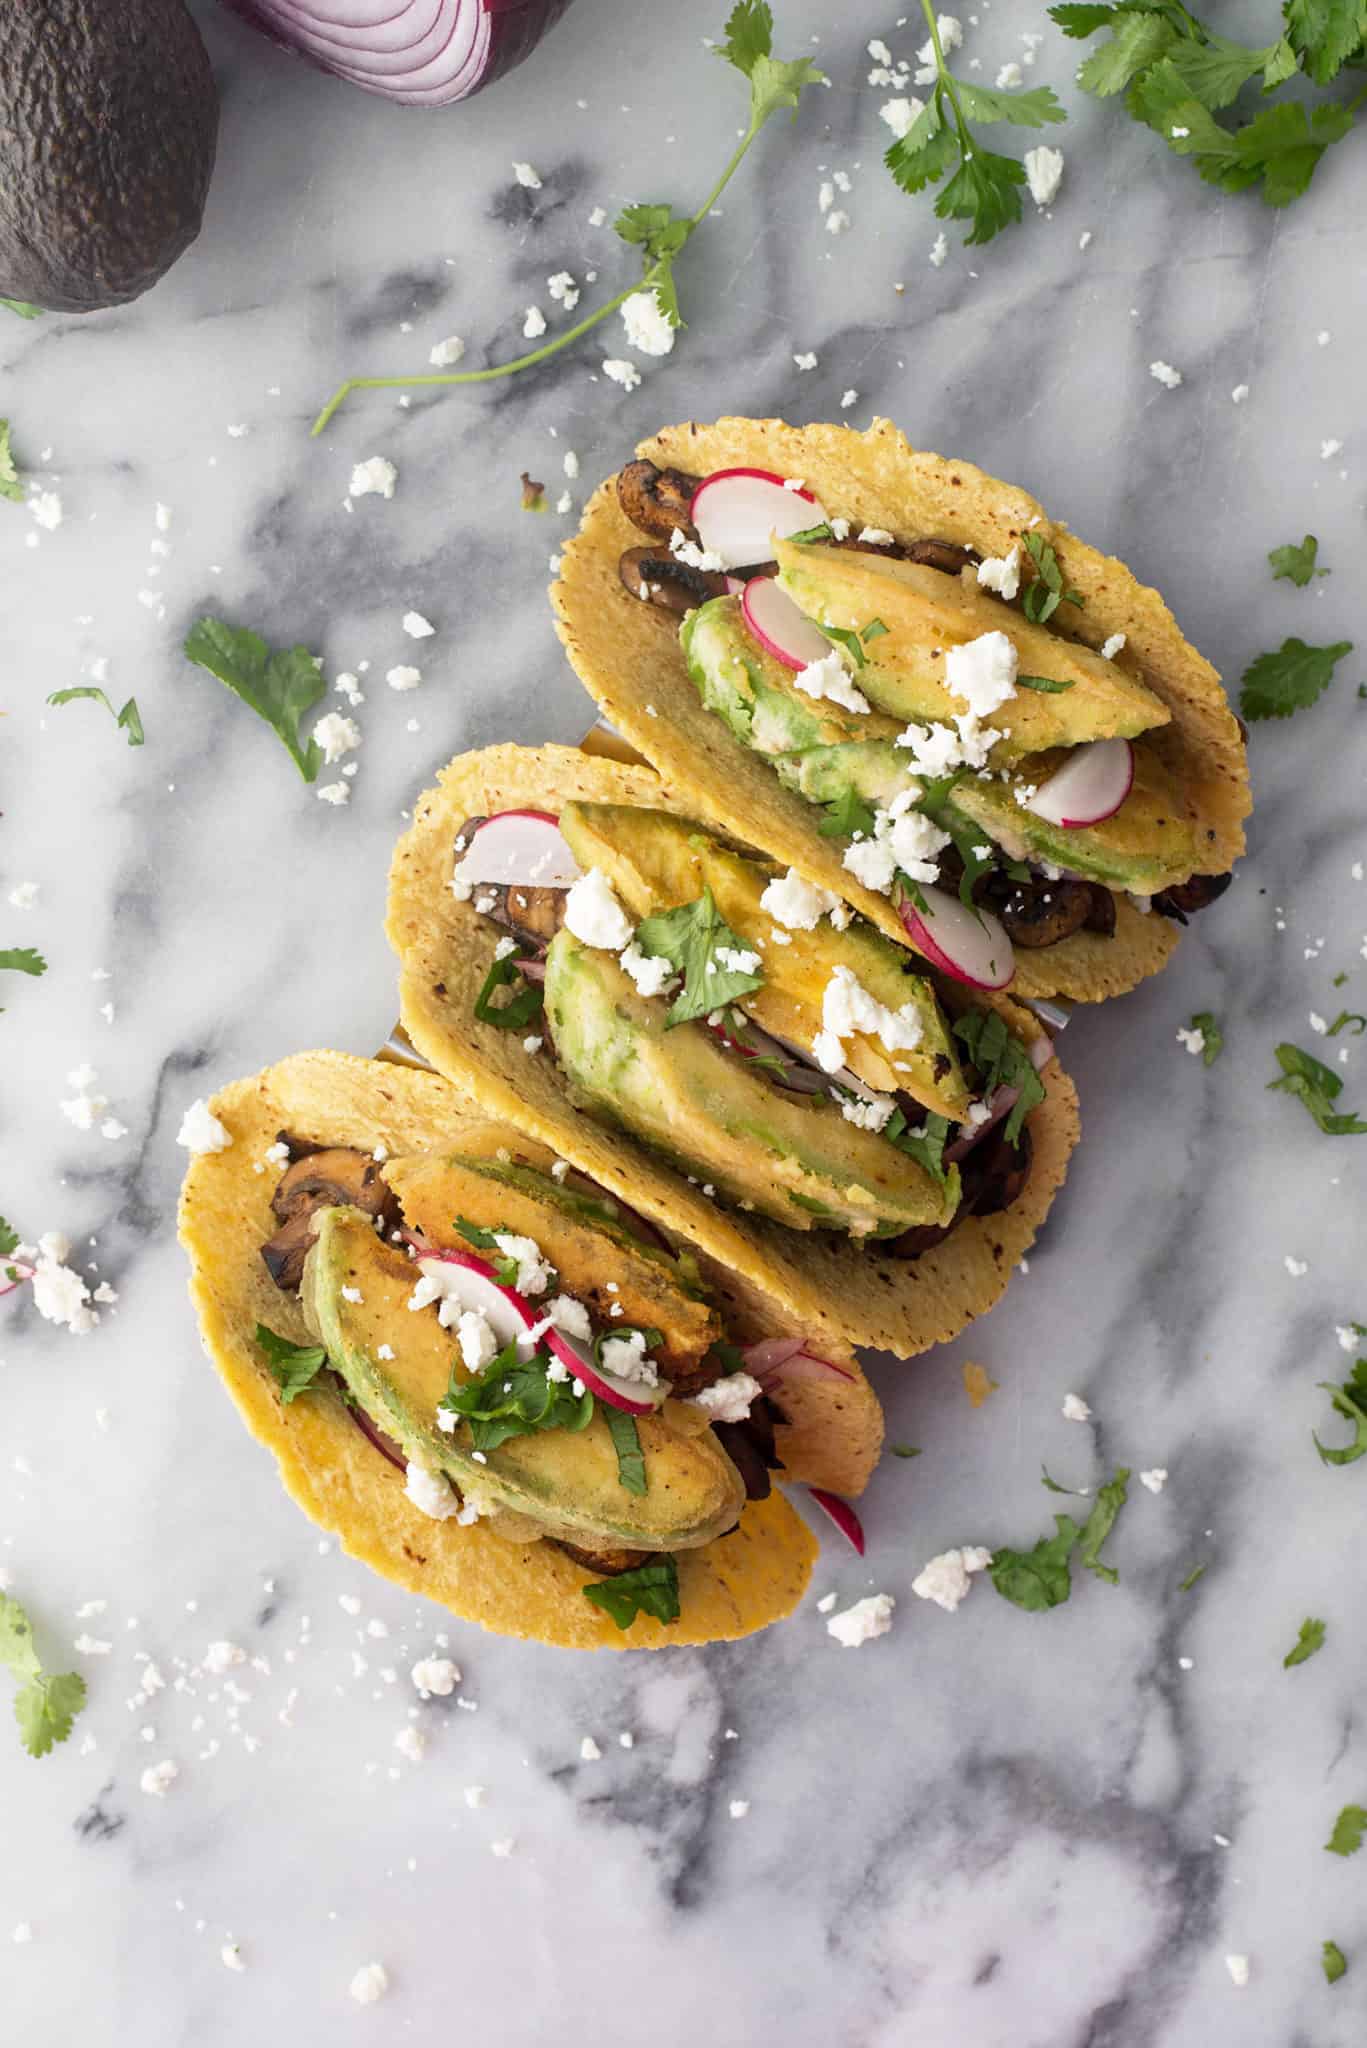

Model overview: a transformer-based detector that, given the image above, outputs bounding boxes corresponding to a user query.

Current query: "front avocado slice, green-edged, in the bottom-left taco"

[301,1208,746,1550]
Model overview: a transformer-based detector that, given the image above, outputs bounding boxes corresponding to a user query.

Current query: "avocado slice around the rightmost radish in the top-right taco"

[953,741,1197,895]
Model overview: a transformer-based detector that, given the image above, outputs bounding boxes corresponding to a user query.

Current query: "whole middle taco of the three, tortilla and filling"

[387,745,1078,1358]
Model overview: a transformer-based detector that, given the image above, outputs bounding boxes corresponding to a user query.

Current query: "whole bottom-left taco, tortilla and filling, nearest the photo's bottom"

[180,1053,883,1649]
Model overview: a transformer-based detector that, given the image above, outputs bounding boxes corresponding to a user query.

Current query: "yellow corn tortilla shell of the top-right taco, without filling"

[551,420,1250,1001]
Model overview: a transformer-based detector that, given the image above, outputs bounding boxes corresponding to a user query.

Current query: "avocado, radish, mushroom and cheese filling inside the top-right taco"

[617,461,1230,987]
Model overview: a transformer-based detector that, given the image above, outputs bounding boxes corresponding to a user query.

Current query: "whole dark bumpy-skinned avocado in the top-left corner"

[0,0,219,313]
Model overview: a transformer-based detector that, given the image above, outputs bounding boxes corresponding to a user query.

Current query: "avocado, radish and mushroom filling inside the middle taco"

[451,801,1051,1257]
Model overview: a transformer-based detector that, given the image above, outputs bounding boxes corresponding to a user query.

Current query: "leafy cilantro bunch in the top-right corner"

[1049,0,1367,207]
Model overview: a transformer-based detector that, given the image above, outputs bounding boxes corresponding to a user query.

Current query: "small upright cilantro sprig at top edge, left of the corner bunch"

[883,0,1068,244]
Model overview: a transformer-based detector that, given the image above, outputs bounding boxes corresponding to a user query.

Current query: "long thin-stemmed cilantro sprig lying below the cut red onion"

[314,0,828,434]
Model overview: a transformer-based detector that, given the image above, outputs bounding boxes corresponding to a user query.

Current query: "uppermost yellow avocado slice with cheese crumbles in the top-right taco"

[775,539,1172,758]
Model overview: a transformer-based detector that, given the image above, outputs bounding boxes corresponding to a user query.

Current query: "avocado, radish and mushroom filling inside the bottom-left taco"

[256,1126,836,1630]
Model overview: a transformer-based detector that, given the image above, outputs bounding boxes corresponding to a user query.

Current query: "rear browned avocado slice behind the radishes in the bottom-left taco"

[383,1151,721,1380]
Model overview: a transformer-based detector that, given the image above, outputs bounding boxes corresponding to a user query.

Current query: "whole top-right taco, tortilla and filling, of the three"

[551,420,1250,1001]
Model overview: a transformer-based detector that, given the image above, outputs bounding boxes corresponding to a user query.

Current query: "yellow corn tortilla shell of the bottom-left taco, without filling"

[180,1053,823,1649]
